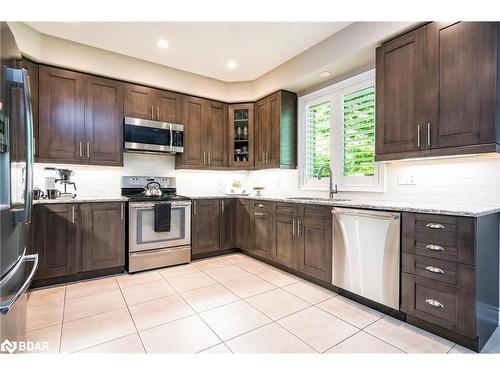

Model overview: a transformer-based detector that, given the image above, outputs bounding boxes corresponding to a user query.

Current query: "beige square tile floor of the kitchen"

[27,254,500,353]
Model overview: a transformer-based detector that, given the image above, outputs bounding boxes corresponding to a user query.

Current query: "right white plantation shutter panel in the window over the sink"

[342,86,375,177]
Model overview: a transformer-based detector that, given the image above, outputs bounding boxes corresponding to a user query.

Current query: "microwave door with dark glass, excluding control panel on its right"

[123,117,172,152]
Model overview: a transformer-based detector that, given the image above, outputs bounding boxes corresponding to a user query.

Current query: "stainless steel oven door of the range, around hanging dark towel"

[129,201,191,252]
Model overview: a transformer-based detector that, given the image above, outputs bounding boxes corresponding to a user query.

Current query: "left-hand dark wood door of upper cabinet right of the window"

[376,26,426,160]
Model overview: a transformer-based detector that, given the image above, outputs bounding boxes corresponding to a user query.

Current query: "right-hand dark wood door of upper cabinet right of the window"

[426,22,497,148]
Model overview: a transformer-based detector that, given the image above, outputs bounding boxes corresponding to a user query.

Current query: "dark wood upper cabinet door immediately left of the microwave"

[85,76,123,165]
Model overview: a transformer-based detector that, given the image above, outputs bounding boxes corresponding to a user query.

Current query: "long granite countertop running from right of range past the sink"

[190,195,500,217]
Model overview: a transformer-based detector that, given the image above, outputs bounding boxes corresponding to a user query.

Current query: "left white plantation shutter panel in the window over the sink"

[305,101,332,178]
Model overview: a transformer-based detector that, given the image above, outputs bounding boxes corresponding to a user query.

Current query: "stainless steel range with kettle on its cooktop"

[122,176,191,272]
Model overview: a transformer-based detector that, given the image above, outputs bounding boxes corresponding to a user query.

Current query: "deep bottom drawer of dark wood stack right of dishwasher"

[401,272,475,337]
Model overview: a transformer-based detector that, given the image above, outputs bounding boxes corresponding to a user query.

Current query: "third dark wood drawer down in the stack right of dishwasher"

[402,252,474,289]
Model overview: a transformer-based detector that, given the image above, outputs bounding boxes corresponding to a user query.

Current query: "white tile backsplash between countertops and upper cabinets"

[34,153,500,206]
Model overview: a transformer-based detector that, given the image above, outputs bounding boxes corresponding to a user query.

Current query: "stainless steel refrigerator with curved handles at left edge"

[0,22,38,353]
